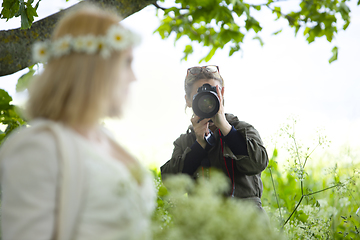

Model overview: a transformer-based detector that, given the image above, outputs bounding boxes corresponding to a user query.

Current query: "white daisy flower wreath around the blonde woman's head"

[33,25,140,62]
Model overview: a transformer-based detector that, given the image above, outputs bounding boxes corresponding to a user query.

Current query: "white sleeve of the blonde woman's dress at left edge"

[0,131,58,240]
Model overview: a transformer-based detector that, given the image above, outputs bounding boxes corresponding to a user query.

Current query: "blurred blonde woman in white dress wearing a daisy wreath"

[0,5,155,240]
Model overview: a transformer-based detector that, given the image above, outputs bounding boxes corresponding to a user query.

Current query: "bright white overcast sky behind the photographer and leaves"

[0,0,360,166]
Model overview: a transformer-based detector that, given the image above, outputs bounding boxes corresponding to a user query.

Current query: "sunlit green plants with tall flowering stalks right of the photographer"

[262,119,360,239]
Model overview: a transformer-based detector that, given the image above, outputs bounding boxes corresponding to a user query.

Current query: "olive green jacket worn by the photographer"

[161,114,269,200]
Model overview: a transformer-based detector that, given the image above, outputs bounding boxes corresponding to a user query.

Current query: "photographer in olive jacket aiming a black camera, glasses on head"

[161,65,269,209]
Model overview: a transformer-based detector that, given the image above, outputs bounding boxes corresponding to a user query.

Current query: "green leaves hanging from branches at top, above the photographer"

[155,0,360,63]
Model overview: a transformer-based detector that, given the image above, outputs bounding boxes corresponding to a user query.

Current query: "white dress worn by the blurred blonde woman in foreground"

[0,120,156,240]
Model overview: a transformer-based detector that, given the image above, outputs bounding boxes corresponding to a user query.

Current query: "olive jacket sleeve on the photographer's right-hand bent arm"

[224,125,269,175]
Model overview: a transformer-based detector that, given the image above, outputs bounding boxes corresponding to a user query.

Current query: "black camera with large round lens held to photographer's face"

[192,83,220,118]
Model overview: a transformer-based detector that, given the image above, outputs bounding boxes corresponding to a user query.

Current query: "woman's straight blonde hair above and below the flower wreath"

[27,4,129,126]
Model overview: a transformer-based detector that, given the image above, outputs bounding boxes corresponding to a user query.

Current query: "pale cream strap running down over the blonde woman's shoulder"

[32,121,85,240]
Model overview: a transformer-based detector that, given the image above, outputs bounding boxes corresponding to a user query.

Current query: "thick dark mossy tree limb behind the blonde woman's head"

[0,0,156,76]
